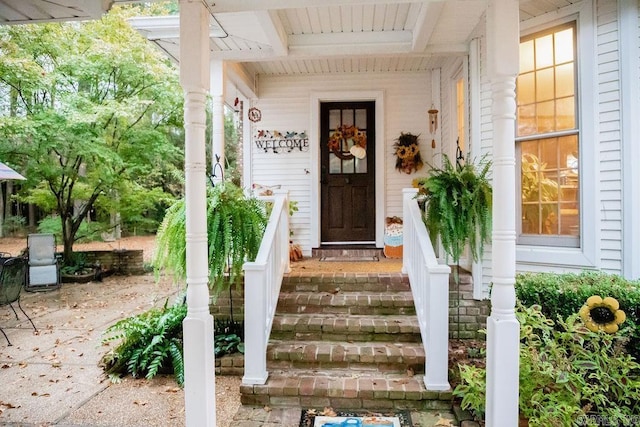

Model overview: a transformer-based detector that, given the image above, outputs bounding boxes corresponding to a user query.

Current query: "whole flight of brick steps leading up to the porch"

[240,273,452,410]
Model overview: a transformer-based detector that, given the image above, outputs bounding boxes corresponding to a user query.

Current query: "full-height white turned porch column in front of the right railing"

[486,0,520,427]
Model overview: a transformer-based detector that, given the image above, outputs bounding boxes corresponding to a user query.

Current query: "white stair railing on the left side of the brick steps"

[242,190,290,384]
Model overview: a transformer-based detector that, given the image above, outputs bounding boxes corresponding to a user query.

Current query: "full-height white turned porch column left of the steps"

[180,0,216,427]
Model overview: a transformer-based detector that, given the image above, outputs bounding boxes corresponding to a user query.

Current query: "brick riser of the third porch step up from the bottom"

[271,330,421,343]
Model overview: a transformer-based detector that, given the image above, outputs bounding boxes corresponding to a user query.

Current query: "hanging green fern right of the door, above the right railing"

[417,155,492,264]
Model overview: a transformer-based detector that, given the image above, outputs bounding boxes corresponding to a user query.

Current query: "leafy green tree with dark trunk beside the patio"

[0,8,183,260]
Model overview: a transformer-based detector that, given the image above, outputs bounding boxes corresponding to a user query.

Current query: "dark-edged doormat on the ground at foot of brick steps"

[300,408,413,427]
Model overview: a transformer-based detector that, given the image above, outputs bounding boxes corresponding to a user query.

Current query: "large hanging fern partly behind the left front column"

[153,182,267,294]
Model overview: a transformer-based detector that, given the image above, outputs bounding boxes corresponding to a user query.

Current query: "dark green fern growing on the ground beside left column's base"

[101,302,187,385]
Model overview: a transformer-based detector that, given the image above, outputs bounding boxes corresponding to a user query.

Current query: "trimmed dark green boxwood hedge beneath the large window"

[516,272,640,360]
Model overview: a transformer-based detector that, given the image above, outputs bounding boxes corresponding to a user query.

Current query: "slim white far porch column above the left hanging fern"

[209,59,226,183]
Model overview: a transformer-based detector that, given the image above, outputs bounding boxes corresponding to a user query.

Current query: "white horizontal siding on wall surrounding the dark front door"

[250,73,431,255]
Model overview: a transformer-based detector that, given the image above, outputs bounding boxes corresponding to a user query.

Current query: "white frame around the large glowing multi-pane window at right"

[516,1,599,268]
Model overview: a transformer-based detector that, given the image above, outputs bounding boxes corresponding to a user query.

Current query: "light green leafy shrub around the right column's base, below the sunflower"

[453,304,640,427]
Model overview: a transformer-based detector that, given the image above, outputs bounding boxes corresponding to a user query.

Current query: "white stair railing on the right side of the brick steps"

[402,188,451,390]
